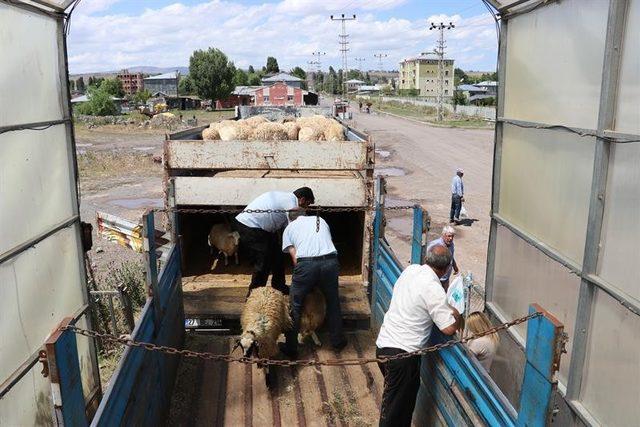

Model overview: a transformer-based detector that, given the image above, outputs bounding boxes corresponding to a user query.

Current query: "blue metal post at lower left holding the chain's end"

[45,317,87,426]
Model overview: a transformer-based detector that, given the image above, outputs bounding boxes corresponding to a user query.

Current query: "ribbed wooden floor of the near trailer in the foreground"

[167,331,383,427]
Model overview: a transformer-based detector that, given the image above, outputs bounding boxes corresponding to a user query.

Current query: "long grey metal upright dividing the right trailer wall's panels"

[567,0,629,400]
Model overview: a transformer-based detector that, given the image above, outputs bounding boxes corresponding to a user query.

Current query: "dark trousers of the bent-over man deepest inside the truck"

[236,221,289,295]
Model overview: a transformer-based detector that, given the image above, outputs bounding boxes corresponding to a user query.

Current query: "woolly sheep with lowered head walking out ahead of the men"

[238,286,291,387]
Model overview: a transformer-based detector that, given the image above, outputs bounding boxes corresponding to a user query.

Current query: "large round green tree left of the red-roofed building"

[189,47,236,101]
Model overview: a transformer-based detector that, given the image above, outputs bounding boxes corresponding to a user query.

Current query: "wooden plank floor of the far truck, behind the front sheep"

[182,274,371,328]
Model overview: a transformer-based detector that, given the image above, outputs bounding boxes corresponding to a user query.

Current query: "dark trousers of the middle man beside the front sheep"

[286,258,345,352]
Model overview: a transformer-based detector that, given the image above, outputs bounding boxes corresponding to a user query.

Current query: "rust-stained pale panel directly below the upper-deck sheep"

[165,140,367,170]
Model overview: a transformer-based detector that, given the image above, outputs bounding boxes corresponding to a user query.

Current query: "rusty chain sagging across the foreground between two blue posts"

[62,312,542,367]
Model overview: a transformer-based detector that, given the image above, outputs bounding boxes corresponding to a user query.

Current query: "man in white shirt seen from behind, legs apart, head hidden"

[282,212,347,358]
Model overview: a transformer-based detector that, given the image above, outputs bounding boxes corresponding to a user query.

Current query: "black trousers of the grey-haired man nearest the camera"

[376,347,420,427]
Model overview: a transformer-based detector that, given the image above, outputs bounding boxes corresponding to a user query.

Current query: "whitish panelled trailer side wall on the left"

[0,1,100,425]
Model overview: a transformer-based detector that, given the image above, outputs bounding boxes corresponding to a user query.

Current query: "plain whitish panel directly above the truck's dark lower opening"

[175,176,368,206]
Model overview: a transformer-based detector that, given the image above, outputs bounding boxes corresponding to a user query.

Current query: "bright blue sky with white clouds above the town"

[68,0,497,73]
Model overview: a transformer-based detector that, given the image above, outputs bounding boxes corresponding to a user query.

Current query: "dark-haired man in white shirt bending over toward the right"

[236,187,314,295]
